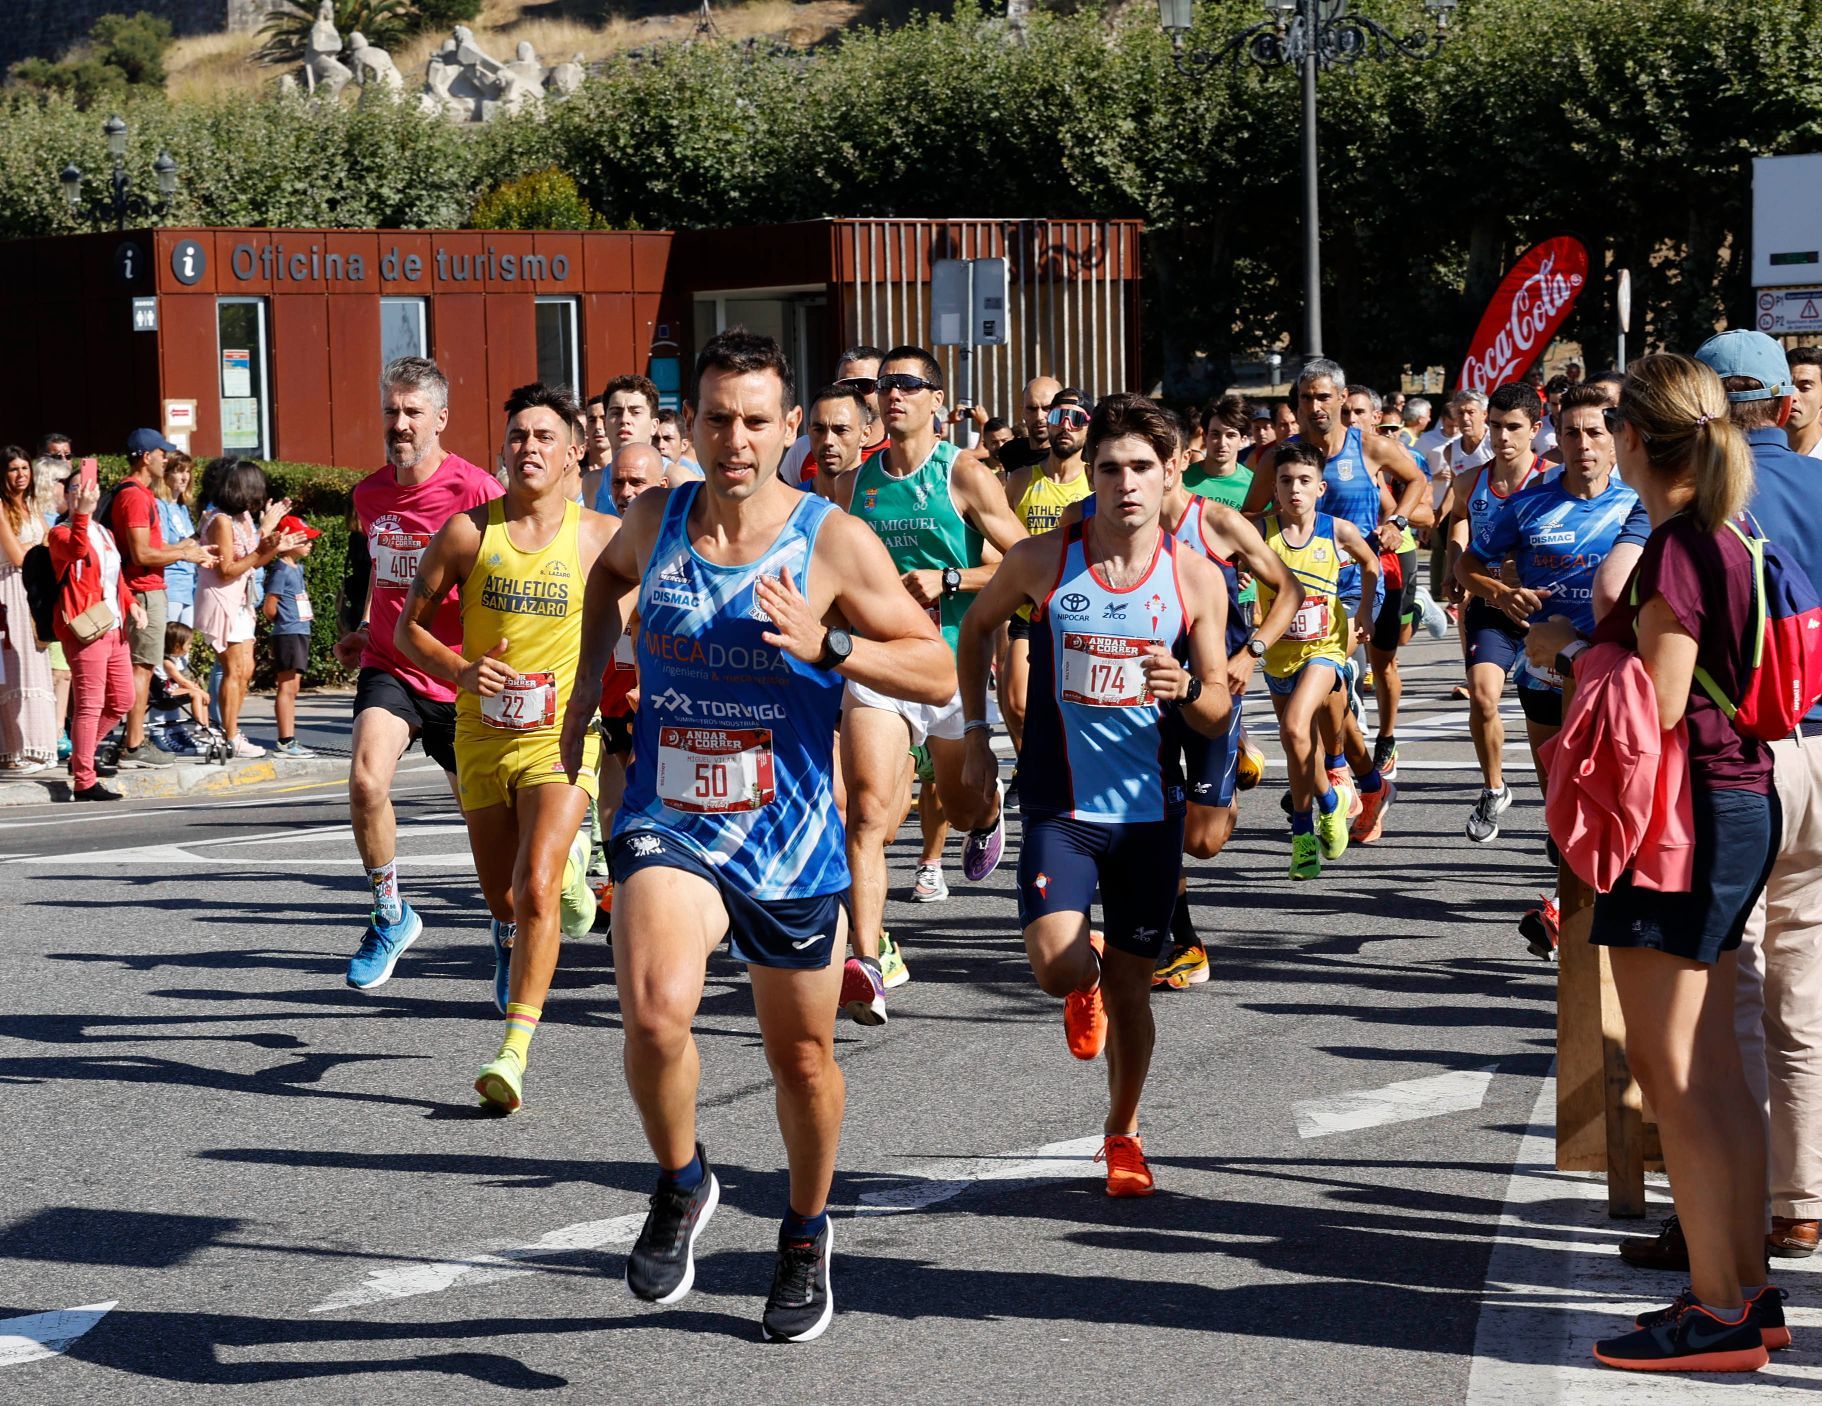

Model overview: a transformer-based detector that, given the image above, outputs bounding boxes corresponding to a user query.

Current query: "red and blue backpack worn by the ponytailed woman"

[1668,514,1822,741]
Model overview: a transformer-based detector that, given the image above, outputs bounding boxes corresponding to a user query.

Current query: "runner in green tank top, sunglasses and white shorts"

[836,346,1026,1025]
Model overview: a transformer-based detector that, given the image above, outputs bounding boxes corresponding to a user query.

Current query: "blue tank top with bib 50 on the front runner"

[614,483,849,900]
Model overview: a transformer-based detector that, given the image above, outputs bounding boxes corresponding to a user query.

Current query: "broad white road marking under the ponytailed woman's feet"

[1467,1076,1822,1406]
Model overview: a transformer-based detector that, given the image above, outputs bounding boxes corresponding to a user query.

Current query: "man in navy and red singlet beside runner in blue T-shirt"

[1443,381,1545,845]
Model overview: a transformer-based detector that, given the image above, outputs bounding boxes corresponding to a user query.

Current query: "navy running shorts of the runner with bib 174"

[1018,816,1182,962]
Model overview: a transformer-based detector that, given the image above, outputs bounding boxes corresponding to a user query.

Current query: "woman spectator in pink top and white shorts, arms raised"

[197,459,292,758]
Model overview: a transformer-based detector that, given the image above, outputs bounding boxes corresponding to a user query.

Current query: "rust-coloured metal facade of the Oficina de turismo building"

[0,219,1139,466]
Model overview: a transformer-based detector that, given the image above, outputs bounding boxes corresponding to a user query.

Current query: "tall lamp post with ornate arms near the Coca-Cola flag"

[1157,0,1459,359]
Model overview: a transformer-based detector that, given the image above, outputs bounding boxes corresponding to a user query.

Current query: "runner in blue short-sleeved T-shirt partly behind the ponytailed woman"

[1456,386,1651,958]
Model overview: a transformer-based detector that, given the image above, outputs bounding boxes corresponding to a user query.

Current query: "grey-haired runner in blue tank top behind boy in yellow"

[1246,357,1436,843]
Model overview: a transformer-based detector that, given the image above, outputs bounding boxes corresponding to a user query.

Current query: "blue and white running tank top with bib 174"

[1018,523,1188,825]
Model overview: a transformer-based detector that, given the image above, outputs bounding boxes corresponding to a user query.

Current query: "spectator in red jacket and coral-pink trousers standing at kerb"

[49,479,144,801]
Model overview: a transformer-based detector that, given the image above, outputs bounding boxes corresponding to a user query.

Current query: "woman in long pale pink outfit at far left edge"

[0,444,58,776]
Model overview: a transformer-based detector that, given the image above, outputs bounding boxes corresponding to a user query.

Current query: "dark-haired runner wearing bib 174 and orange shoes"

[957,395,1232,1197]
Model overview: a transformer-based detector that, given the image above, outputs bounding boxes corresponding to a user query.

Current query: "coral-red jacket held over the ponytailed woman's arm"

[1538,645,1694,892]
